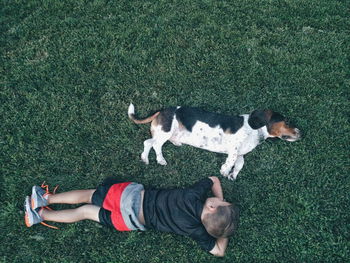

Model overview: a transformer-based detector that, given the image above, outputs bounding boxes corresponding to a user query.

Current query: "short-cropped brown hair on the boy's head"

[203,204,239,238]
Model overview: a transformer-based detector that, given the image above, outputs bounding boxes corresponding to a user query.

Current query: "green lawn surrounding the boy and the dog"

[0,0,350,263]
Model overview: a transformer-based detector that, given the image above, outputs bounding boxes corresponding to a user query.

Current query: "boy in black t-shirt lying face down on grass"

[25,176,238,257]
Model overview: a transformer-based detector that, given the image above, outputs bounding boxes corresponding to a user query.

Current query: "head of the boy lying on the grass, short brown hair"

[201,197,239,238]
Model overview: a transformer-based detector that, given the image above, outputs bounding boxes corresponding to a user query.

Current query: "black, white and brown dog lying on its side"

[128,104,301,180]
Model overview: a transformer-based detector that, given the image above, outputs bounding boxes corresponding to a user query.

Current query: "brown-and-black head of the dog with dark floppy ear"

[248,110,301,142]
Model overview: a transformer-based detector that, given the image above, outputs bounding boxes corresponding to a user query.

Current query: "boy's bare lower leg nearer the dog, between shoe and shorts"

[47,189,96,204]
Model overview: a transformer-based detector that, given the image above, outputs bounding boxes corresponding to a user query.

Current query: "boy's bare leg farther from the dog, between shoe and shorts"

[41,204,100,223]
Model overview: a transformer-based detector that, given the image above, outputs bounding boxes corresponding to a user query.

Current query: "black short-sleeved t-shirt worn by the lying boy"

[143,178,216,251]
